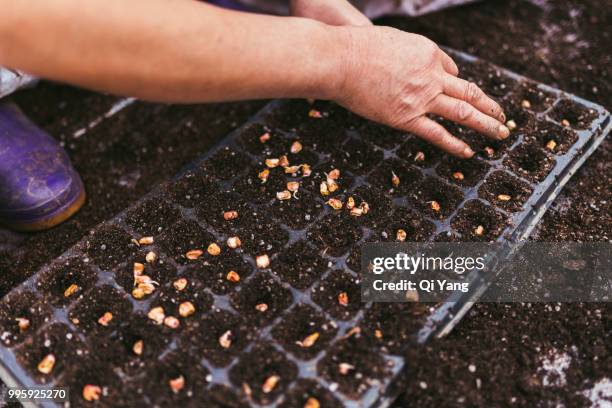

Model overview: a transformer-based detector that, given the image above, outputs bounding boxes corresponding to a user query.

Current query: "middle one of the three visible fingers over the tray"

[431,94,510,139]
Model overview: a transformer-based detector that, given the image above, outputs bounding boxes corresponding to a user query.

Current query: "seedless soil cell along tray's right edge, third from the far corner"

[504,143,555,181]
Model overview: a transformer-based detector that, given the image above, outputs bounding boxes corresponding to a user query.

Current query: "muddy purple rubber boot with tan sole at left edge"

[0,103,85,231]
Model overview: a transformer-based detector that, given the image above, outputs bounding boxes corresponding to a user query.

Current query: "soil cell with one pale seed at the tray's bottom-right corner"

[317,333,388,399]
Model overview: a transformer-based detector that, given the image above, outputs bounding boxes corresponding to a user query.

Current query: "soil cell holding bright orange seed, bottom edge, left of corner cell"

[229,343,298,404]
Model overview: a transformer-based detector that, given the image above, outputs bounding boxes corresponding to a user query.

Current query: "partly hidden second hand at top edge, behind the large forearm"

[291,0,372,26]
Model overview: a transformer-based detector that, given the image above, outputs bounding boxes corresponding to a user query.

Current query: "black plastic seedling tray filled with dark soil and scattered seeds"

[0,52,611,407]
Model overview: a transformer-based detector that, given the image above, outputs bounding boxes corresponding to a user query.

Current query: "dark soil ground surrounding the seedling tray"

[0,0,612,407]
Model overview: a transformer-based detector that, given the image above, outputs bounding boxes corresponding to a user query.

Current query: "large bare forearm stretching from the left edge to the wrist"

[0,0,343,102]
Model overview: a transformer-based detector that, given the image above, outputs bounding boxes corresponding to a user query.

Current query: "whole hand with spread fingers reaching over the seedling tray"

[332,27,510,158]
